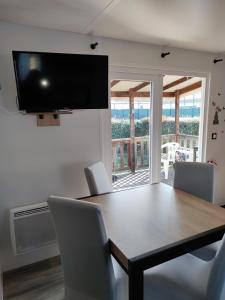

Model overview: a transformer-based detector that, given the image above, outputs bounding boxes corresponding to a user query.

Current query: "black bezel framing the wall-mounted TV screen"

[12,50,109,114]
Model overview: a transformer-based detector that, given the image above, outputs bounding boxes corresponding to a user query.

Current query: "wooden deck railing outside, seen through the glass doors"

[112,134,198,172]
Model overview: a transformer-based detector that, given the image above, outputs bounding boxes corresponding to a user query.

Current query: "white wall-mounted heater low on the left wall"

[10,202,56,255]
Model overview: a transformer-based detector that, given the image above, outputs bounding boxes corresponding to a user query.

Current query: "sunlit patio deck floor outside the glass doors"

[113,166,174,190]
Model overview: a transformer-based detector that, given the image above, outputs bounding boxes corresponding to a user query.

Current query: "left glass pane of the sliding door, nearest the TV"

[111,80,151,189]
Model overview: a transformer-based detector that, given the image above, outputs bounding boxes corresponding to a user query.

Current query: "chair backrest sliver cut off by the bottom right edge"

[207,235,225,300]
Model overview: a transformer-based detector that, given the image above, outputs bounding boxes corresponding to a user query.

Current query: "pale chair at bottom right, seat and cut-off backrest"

[145,238,225,300]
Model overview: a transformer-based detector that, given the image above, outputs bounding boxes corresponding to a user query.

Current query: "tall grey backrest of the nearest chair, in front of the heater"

[48,196,115,300]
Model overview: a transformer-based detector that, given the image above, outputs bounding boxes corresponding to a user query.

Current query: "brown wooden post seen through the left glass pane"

[129,90,135,173]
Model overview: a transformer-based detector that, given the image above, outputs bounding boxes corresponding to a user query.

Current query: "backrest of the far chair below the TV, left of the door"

[84,161,112,195]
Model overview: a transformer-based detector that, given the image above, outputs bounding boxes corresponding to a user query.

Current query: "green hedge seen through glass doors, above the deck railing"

[112,118,199,139]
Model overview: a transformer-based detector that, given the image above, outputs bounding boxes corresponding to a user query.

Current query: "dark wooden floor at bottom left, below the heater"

[3,261,64,300]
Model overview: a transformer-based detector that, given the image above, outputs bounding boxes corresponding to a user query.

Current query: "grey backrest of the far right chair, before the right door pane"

[174,162,214,202]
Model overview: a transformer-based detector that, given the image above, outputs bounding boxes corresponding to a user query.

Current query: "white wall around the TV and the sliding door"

[0,22,225,270]
